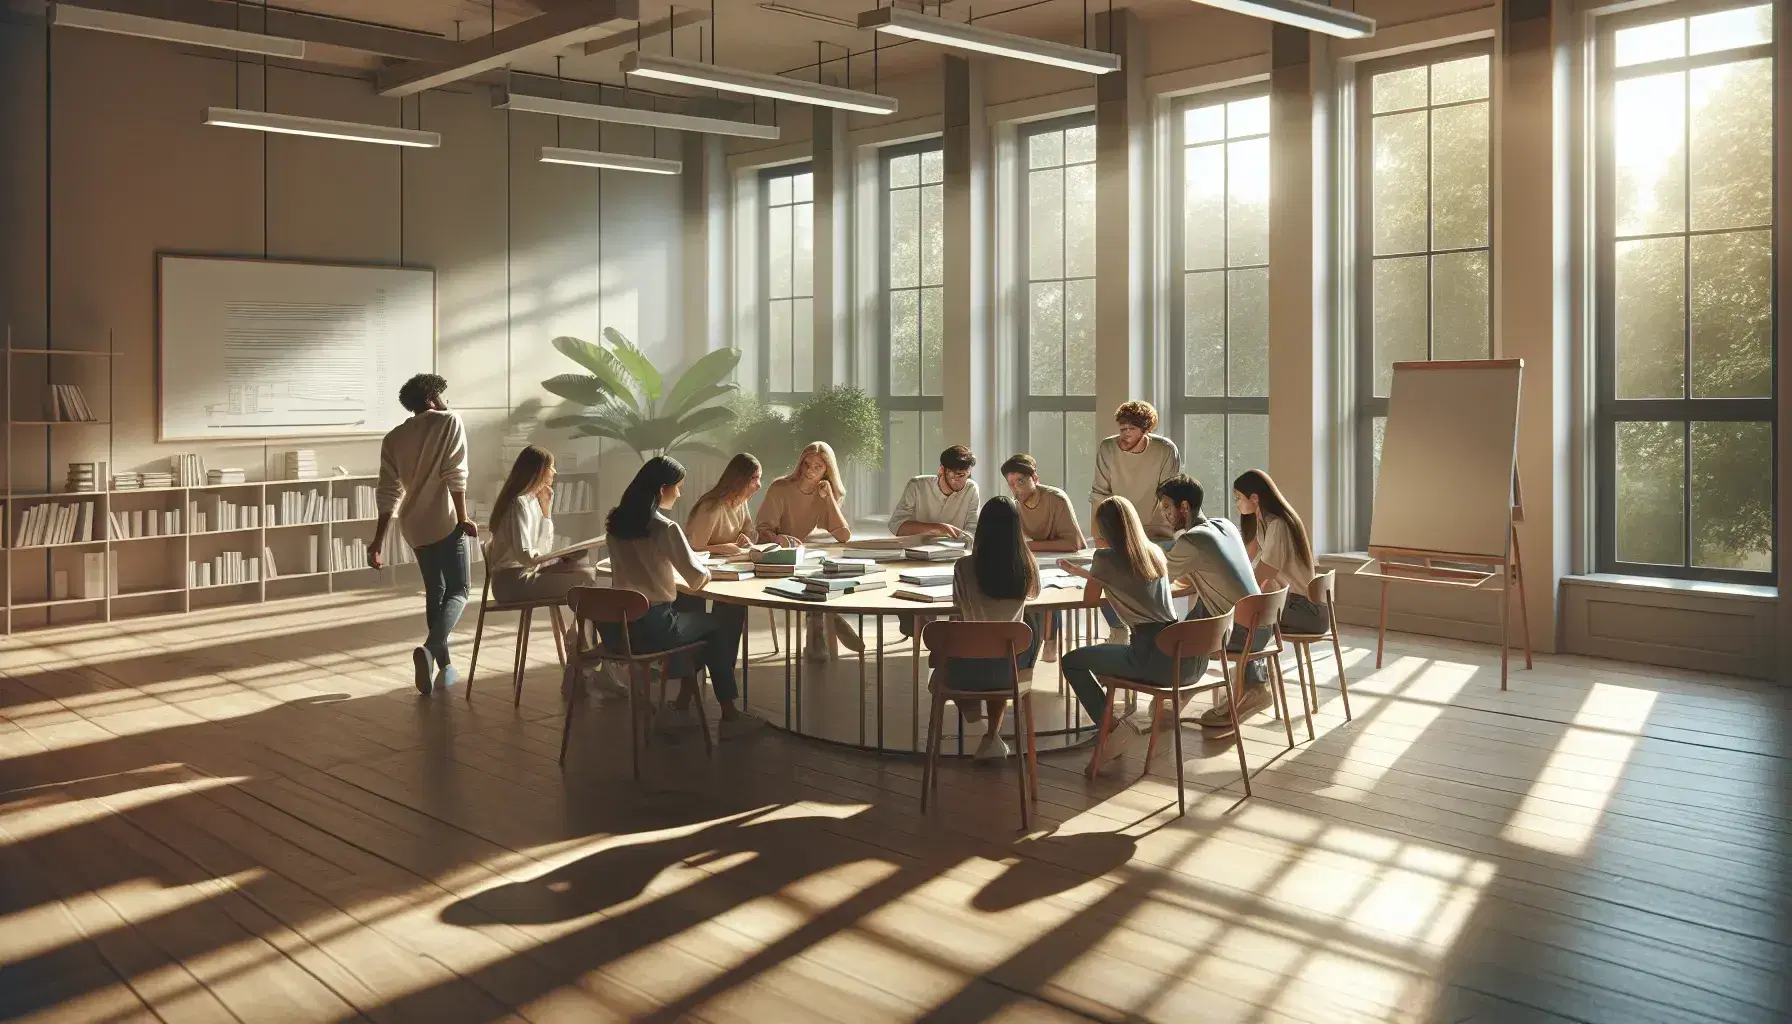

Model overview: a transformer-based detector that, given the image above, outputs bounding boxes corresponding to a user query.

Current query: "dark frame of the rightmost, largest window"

[1591,0,1785,586]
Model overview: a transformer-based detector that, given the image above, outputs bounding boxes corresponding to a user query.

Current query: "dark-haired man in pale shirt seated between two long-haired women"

[1158,477,1272,739]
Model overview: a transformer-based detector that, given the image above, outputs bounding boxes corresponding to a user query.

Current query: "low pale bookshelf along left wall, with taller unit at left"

[0,330,451,635]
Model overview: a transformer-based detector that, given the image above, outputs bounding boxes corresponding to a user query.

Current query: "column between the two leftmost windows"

[812,106,853,391]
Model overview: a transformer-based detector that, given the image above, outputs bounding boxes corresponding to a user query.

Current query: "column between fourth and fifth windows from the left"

[1261,25,1344,551]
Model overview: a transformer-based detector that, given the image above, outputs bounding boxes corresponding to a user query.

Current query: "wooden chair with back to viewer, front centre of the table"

[921,619,1039,829]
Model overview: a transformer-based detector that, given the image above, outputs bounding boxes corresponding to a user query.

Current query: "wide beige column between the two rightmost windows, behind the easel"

[1493,0,1573,651]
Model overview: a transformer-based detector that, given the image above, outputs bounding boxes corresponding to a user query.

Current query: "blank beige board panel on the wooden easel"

[1369,359,1523,560]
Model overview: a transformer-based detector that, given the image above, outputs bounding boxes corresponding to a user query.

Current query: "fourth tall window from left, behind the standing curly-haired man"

[1163,90,1269,508]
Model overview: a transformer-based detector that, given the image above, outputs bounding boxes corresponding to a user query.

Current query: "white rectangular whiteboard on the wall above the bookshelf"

[156,256,435,441]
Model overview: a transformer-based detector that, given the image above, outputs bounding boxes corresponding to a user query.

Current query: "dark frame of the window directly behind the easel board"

[1349,39,1500,551]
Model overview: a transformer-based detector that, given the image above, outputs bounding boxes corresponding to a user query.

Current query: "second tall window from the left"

[878,140,946,506]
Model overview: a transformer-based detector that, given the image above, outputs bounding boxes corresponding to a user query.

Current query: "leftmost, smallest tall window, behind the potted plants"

[760,165,815,402]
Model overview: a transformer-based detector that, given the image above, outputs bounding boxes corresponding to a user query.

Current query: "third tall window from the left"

[1018,115,1097,508]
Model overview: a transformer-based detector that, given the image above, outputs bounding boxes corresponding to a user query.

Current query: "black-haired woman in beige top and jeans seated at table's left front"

[599,456,765,739]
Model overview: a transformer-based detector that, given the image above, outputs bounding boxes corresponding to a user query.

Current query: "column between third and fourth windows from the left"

[1095,7,1163,438]
